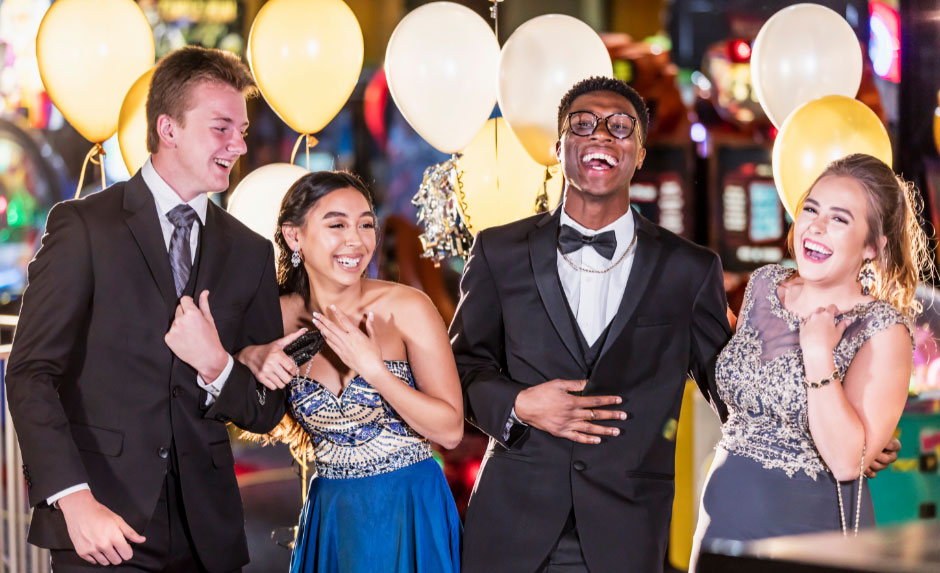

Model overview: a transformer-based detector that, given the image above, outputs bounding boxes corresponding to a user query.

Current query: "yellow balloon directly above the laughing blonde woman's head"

[773,95,892,217]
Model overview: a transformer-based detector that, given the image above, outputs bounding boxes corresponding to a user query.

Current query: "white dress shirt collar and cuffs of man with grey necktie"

[46,157,235,505]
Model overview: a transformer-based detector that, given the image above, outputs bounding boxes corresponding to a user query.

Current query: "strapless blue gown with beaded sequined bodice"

[288,361,461,573]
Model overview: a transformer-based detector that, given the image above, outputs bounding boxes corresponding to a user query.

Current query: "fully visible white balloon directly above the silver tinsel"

[385,2,499,153]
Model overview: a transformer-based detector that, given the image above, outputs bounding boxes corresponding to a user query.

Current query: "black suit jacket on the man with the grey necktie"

[6,173,284,570]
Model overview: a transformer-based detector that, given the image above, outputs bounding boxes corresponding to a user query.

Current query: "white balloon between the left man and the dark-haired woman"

[228,163,309,250]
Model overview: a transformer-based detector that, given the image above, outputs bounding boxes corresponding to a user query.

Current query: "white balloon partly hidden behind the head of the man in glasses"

[499,14,614,165]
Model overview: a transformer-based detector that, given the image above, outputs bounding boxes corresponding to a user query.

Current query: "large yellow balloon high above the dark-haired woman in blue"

[248,0,363,133]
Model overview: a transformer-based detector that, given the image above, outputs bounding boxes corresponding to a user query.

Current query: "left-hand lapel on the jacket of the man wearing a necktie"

[124,171,176,309]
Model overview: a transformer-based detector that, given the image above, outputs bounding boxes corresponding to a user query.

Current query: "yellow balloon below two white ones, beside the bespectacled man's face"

[460,117,562,233]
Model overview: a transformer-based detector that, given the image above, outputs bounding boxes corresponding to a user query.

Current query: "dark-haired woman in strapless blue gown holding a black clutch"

[238,172,463,573]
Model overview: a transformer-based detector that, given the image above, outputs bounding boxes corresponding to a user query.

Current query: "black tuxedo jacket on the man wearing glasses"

[451,207,731,573]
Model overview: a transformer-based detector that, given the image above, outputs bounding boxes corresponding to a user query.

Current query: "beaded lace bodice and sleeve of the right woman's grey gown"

[716,265,913,480]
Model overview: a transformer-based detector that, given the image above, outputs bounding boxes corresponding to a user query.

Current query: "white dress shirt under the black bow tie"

[556,209,636,345]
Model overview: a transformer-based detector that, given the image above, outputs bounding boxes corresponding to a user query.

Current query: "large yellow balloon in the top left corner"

[36,0,154,143]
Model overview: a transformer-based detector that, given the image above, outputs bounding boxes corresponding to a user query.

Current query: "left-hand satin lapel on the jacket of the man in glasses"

[529,206,587,370]
